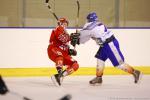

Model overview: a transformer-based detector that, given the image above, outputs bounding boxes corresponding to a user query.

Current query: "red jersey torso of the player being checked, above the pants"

[49,26,70,53]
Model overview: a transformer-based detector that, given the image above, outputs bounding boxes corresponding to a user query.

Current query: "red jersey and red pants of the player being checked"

[47,26,76,66]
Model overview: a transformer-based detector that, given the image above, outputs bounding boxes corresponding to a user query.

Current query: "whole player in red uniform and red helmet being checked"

[47,18,79,86]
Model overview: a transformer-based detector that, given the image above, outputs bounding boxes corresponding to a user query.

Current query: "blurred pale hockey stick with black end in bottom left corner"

[0,75,32,100]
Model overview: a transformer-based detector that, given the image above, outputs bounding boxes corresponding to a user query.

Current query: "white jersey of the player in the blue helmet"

[80,22,113,44]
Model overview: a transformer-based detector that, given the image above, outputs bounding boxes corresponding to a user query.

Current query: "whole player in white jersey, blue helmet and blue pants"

[71,12,141,84]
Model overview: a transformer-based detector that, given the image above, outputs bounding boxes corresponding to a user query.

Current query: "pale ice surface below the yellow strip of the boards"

[0,75,150,100]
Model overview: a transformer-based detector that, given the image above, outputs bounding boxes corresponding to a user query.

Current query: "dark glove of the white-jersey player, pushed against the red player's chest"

[70,33,80,47]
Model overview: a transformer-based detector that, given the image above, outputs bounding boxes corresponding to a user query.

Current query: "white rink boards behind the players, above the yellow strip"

[0,28,150,68]
